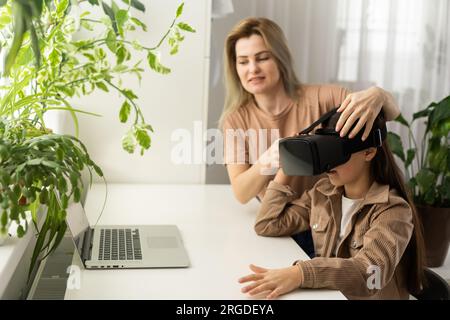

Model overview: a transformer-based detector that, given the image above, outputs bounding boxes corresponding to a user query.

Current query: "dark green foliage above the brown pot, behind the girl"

[387,96,450,208]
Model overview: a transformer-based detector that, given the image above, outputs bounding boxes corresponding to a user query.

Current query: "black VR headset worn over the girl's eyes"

[279,108,387,176]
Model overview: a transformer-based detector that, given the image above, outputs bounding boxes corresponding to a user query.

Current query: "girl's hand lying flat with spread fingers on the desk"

[239,264,302,299]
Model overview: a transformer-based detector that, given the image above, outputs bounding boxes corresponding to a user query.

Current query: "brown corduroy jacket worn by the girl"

[255,178,414,299]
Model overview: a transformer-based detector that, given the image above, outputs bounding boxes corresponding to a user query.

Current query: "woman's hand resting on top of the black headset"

[336,87,386,141]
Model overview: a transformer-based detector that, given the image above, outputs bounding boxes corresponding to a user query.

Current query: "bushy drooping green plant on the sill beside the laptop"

[0,122,103,276]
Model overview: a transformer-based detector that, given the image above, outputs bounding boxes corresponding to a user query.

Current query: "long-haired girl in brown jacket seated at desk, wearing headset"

[239,113,424,299]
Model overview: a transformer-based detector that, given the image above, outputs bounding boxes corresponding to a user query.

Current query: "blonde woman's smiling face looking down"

[235,34,281,94]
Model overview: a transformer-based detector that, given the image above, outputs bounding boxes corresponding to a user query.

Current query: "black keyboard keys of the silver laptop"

[98,229,142,260]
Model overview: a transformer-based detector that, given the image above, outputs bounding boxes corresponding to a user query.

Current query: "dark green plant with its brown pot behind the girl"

[388,96,450,267]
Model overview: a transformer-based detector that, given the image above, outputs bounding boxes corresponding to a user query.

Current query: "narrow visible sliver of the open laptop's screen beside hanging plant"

[66,203,89,257]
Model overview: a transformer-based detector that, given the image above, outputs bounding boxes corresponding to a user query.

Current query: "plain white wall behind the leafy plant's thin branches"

[60,0,210,183]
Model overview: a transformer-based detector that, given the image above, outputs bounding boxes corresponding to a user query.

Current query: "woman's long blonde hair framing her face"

[219,18,300,128]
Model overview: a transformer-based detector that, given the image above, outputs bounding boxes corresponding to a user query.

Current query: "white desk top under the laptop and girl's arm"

[65,184,345,300]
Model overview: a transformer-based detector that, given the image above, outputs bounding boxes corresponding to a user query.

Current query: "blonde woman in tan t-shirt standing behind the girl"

[220,18,400,203]
